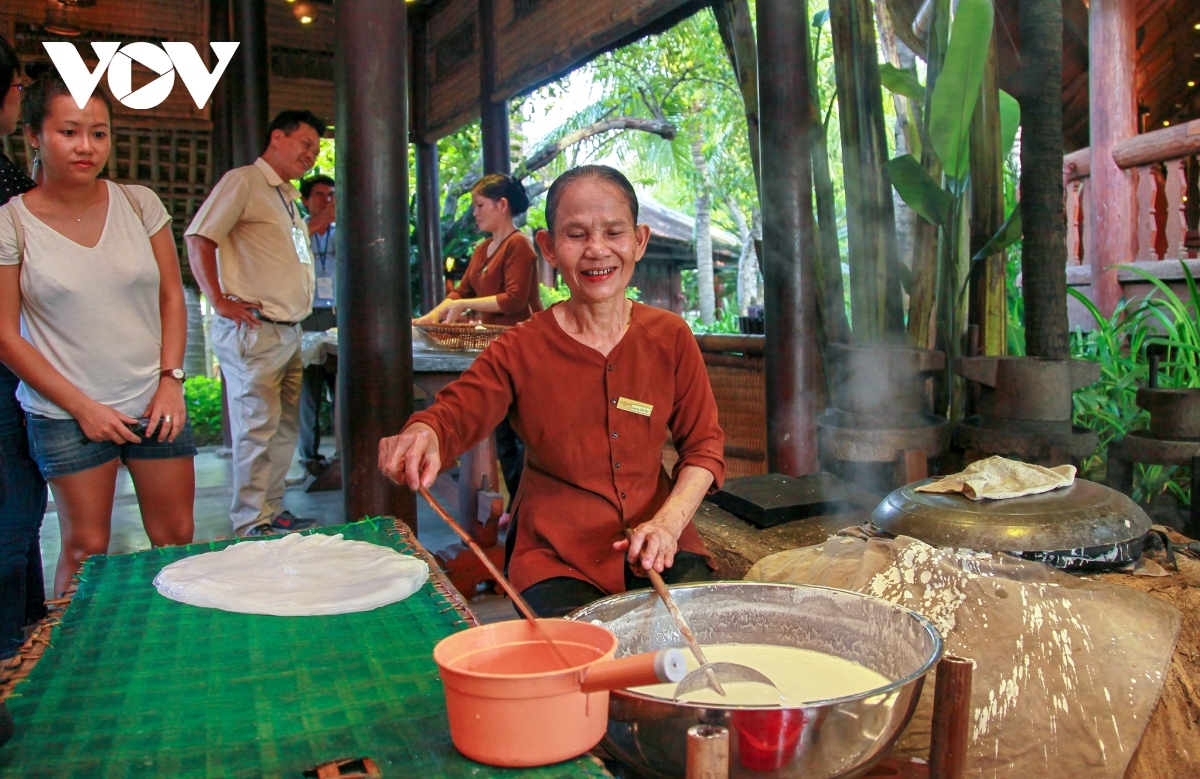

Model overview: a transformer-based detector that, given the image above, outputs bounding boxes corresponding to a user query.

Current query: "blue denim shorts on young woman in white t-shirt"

[25,413,196,479]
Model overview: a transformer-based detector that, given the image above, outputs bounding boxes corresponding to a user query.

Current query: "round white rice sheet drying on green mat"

[154,533,430,617]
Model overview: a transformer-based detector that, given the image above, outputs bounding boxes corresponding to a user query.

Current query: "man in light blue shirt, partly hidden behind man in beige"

[300,175,337,477]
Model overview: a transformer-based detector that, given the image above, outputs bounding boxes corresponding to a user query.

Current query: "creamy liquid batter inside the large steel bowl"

[630,643,892,706]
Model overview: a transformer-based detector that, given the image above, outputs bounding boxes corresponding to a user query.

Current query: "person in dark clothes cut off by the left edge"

[0,37,46,660]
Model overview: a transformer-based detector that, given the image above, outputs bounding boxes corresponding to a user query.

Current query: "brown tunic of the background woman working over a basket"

[446,230,541,325]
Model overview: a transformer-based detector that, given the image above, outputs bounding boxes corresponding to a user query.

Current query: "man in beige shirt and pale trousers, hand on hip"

[185,110,325,535]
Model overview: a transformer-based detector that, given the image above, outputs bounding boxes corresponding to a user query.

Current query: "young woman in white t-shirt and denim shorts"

[0,67,196,593]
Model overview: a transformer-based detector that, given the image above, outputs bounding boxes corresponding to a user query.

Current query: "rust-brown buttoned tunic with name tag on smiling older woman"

[409,302,725,593]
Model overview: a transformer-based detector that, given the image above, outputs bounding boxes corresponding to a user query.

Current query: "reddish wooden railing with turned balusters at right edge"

[1062,120,1200,283]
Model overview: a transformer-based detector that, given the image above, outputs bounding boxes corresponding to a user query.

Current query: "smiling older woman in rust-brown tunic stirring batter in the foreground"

[379,166,725,616]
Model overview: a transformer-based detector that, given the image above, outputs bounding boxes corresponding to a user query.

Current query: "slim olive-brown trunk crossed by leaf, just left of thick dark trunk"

[967,32,1008,354]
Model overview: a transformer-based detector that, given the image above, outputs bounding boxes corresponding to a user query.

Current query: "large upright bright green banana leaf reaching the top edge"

[929,0,994,179]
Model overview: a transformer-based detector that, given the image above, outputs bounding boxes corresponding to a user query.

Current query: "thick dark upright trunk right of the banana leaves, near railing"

[1019,0,1070,360]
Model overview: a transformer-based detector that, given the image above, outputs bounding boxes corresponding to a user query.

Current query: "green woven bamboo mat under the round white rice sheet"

[0,520,608,779]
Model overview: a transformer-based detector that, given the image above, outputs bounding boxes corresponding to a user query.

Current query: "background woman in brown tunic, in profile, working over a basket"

[416,173,541,325]
